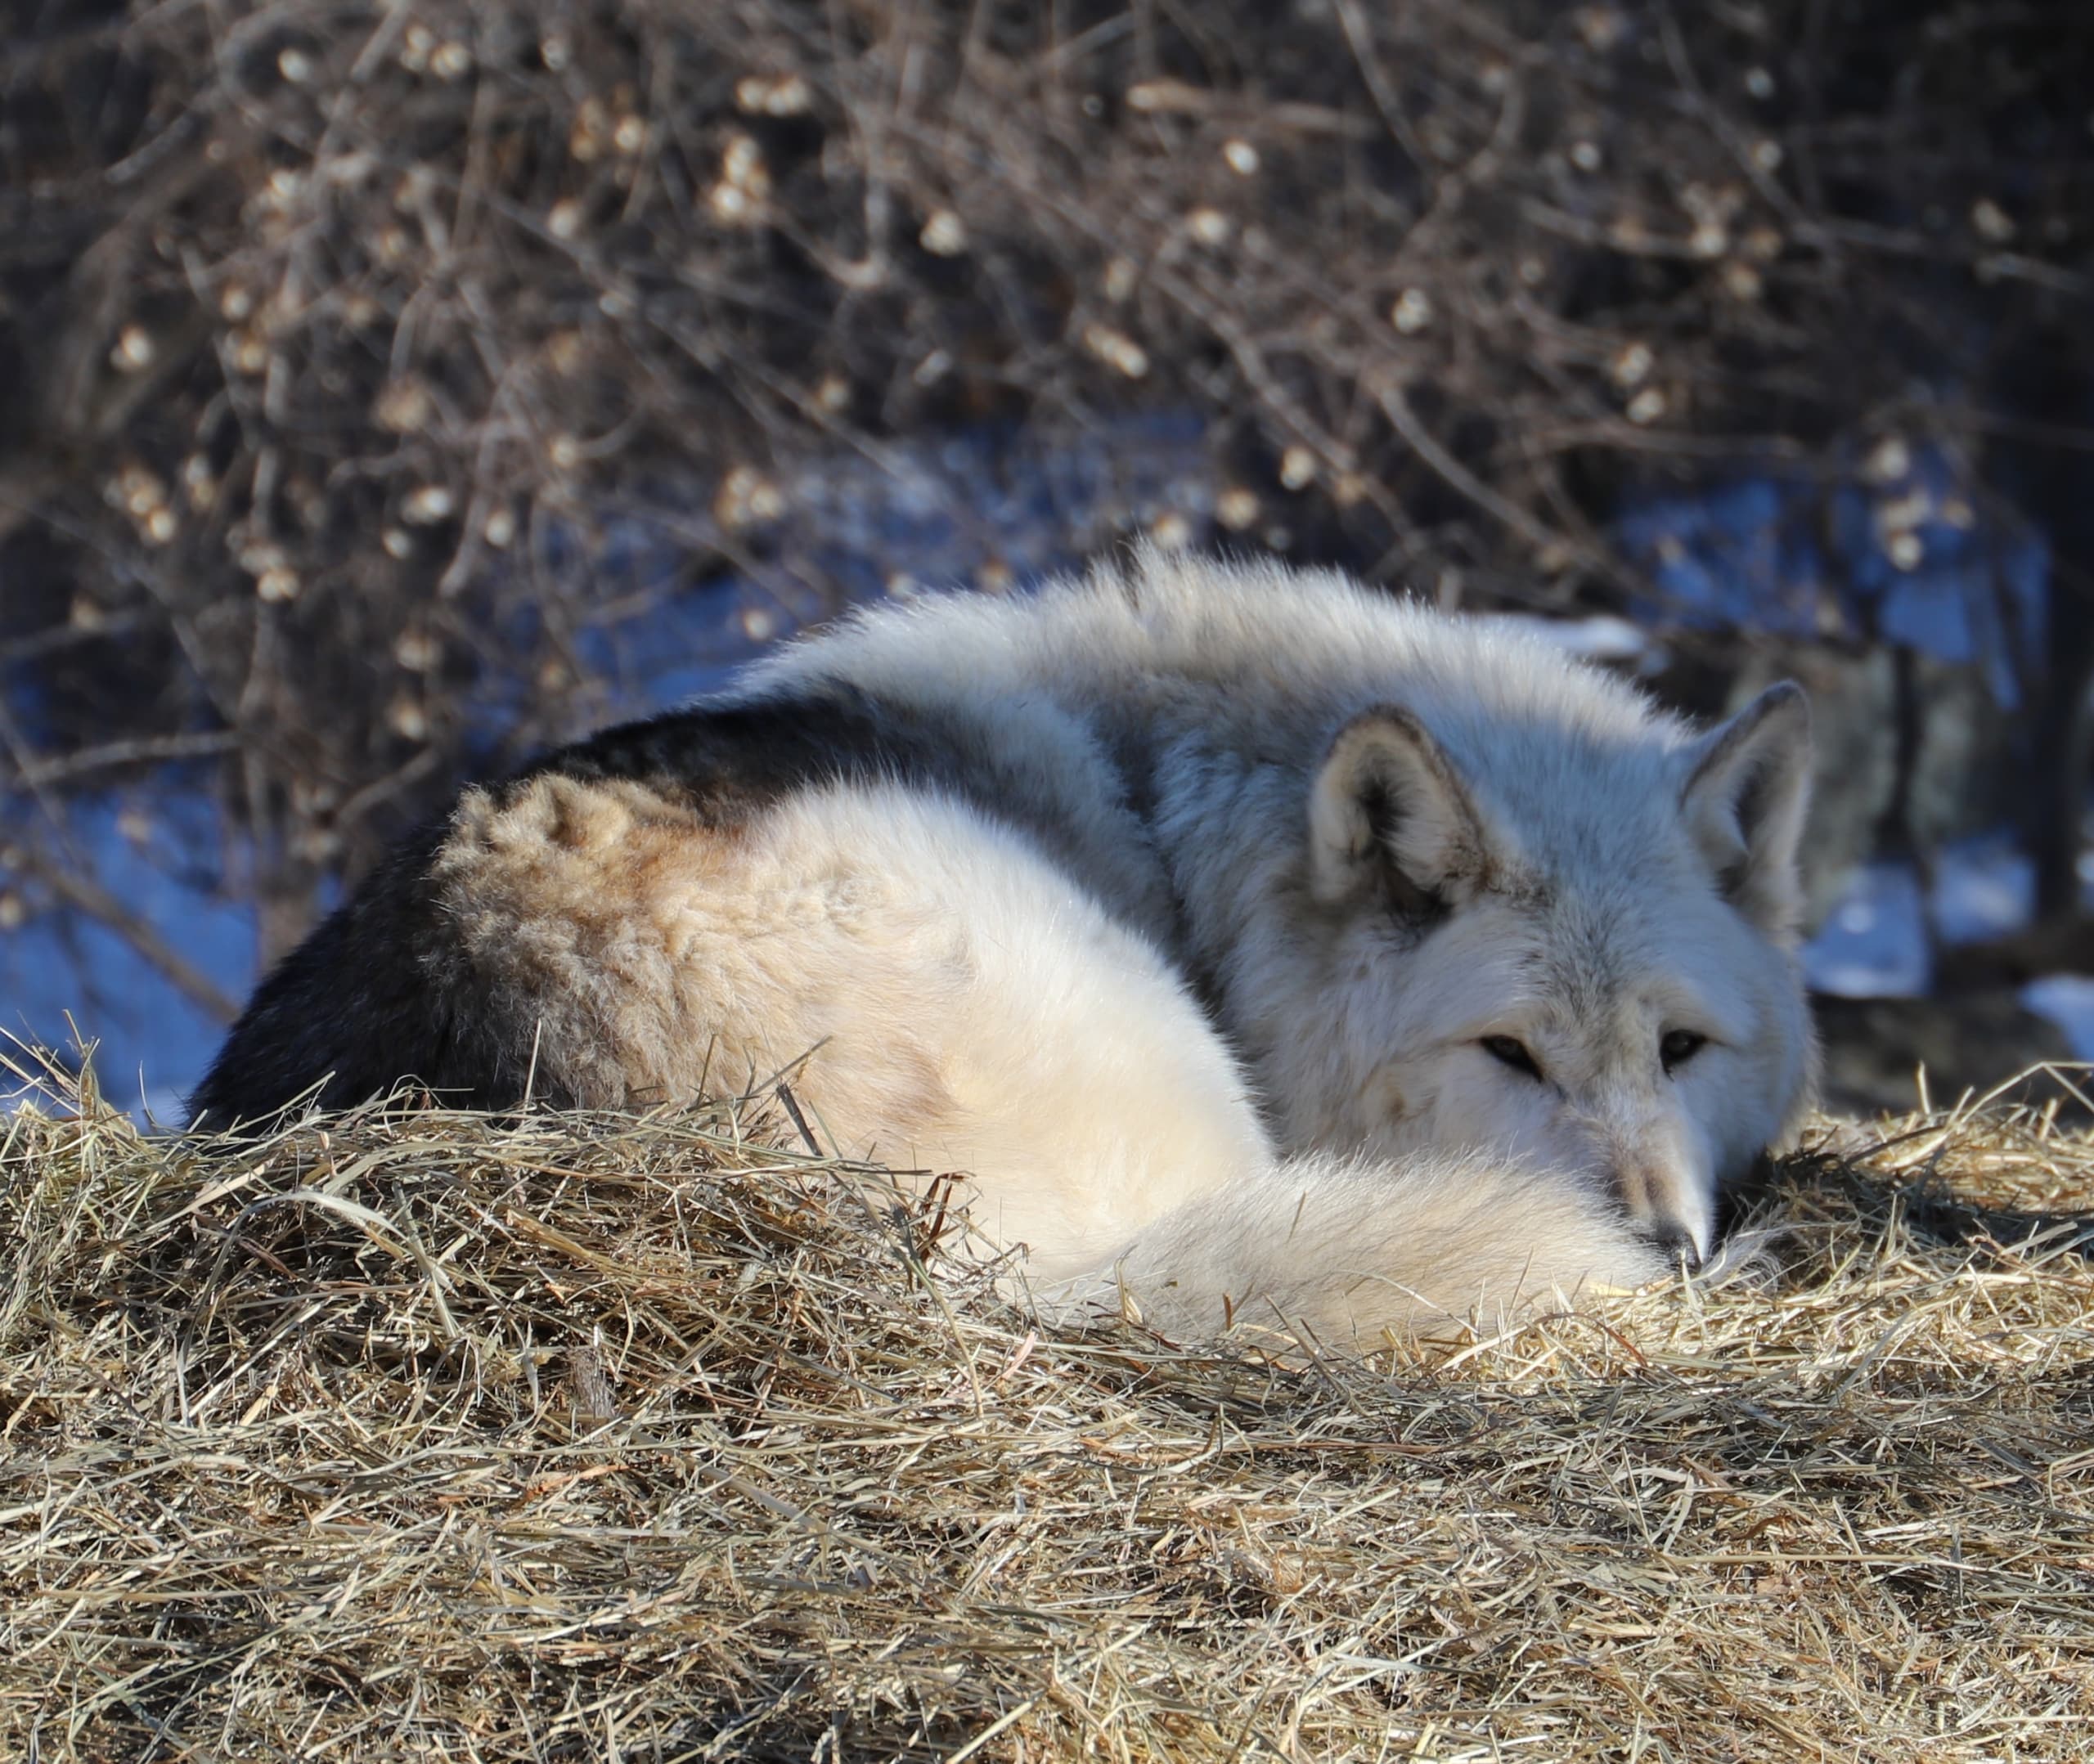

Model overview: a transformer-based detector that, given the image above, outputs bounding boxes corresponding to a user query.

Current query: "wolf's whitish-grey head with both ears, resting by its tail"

[1275,685,1813,1262]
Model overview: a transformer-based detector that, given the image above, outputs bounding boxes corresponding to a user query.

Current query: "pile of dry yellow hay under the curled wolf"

[0,1071,2094,1764]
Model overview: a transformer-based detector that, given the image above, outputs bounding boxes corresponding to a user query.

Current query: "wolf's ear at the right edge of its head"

[1679,680,1811,937]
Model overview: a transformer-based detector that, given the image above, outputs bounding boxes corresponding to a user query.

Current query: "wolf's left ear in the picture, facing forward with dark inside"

[1309,705,1495,913]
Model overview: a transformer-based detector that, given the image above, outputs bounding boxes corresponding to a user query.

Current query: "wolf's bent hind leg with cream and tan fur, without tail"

[438,779,1271,1278]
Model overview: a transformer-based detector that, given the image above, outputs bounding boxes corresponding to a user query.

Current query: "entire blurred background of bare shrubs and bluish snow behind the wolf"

[0,0,2094,1109]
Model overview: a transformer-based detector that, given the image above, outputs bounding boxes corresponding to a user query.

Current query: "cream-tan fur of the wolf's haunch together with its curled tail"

[440,776,1665,1345]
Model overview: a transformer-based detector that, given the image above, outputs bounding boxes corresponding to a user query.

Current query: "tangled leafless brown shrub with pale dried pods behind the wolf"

[0,0,2094,987]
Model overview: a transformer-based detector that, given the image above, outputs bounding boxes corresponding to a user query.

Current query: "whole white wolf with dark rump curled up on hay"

[197,553,1813,1344]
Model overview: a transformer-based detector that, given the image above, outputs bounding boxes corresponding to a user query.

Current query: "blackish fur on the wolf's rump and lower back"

[191,686,1089,1128]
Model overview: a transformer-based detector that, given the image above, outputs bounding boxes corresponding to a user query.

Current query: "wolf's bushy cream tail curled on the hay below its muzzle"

[1036,1153,1669,1349]
